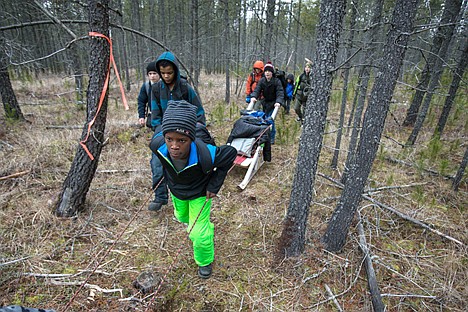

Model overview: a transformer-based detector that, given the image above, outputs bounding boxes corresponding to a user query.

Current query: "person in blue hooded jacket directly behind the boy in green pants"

[148,51,206,211]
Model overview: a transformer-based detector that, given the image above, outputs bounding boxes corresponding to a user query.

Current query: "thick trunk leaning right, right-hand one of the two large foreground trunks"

[323,0,418,252]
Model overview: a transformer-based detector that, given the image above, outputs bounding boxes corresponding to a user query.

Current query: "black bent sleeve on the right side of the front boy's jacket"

[206,145,237,194]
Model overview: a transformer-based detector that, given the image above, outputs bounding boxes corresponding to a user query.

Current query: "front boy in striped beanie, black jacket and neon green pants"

[150,101,237,278]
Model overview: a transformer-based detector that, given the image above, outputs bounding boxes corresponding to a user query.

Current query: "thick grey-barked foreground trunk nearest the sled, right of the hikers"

[278,0,346,257]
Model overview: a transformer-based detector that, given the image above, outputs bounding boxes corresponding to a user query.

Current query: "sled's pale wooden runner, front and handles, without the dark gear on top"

[228,103,279,190]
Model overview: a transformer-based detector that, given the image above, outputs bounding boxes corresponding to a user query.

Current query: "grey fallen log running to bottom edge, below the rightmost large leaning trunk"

[357,216,385,312]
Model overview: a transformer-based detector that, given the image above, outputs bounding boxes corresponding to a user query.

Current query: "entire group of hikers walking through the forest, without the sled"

[138,52,310,278]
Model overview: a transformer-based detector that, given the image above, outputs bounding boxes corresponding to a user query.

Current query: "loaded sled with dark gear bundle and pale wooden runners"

[227,102,278,190]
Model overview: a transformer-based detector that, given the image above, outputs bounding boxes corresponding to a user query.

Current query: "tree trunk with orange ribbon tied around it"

[55,0,110,217]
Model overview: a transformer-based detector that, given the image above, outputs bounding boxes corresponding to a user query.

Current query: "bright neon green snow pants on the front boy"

[171,194,214,266]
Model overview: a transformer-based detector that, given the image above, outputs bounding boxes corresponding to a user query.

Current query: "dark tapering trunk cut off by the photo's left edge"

[0,54,25,121]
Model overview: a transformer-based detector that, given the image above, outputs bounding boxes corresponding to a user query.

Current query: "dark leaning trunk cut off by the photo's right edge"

[434,37,468,137]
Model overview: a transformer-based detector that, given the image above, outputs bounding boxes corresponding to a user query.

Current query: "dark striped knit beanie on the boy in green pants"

[162,101,197,141]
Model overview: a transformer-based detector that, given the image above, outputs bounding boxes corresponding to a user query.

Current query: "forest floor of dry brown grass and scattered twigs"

[0,72,468,311]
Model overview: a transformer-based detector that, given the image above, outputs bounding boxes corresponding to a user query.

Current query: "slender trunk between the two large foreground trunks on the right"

[331,1,358,169]
